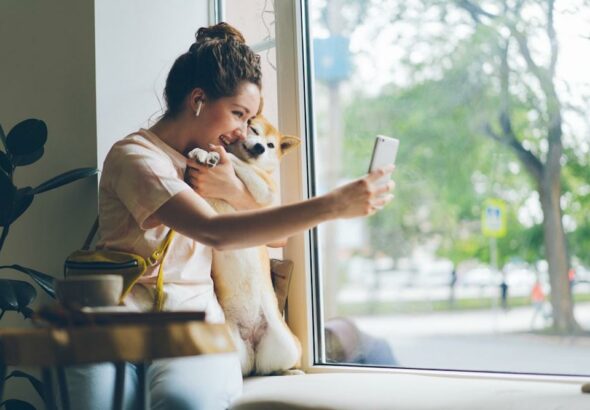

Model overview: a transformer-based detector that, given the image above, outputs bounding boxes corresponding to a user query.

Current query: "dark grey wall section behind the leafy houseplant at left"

[0,0,96,408]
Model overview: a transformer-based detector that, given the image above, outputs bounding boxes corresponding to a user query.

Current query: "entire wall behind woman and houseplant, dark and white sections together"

[0,0,210,408]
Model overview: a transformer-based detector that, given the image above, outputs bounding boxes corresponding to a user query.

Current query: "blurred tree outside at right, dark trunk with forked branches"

[457,0,578,333]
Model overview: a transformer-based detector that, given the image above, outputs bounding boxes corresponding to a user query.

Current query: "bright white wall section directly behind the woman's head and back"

[96,0,209,166]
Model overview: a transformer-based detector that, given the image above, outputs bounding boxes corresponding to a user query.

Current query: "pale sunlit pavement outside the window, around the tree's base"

[354,303,590,375]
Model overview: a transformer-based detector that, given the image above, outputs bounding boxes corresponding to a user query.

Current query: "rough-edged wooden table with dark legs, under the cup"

[0,321,235,410]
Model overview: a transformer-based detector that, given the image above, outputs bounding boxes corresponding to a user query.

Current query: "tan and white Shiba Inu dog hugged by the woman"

[189,115,301,375]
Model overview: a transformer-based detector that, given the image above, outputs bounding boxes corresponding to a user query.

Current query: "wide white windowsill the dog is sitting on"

[232,366,590,410]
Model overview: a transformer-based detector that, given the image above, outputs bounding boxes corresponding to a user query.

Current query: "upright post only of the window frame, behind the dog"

[275,0,324,371]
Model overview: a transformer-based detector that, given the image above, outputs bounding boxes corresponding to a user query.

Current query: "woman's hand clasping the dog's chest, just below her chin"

[185,145,256,209]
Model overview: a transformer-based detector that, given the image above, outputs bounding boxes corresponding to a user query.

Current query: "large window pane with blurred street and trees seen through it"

[303,0,590,374]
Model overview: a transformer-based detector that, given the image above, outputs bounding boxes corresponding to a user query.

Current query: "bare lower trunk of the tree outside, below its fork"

[539,178,579,334]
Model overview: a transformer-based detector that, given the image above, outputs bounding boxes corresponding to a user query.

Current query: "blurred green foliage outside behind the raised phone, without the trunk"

[328,1,590,265]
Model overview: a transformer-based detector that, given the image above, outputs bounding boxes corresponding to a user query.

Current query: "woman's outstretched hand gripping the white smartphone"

[326,165,395,218]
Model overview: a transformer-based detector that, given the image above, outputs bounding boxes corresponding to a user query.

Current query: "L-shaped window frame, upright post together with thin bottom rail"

[275,0,587,384]
